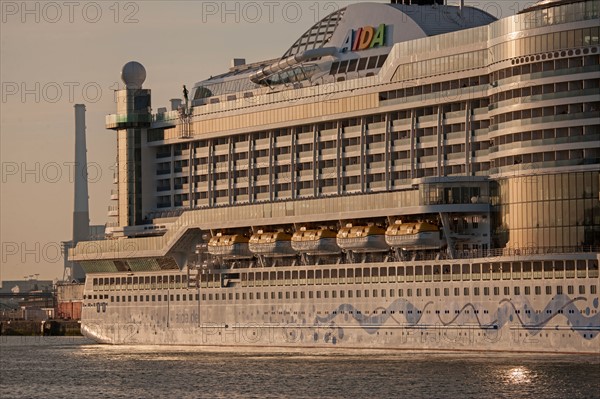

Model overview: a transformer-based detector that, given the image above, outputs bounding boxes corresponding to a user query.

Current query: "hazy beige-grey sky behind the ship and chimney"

[0,0,533,283]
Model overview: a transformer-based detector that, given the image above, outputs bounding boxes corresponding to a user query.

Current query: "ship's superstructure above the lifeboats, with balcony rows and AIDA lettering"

[71,0,600,273]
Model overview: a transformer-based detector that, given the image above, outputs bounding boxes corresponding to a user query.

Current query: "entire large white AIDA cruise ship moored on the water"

[69,0,600,355]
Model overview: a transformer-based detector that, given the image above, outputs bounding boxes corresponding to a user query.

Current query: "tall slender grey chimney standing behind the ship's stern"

[71,104,90,280]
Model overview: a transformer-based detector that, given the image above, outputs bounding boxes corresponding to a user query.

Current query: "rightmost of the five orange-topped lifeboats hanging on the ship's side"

[385,221,445,251]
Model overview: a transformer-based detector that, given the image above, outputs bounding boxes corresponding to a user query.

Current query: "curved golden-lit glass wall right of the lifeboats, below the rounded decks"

[496,171,600,252]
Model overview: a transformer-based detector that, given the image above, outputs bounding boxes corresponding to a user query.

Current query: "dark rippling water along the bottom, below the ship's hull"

[0,337,600,399]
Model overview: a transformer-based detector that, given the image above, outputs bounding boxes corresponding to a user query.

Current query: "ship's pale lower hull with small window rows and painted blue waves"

[82,256,600,354]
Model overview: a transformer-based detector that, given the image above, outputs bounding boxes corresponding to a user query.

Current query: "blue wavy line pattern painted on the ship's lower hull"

[315,295,600,340]
